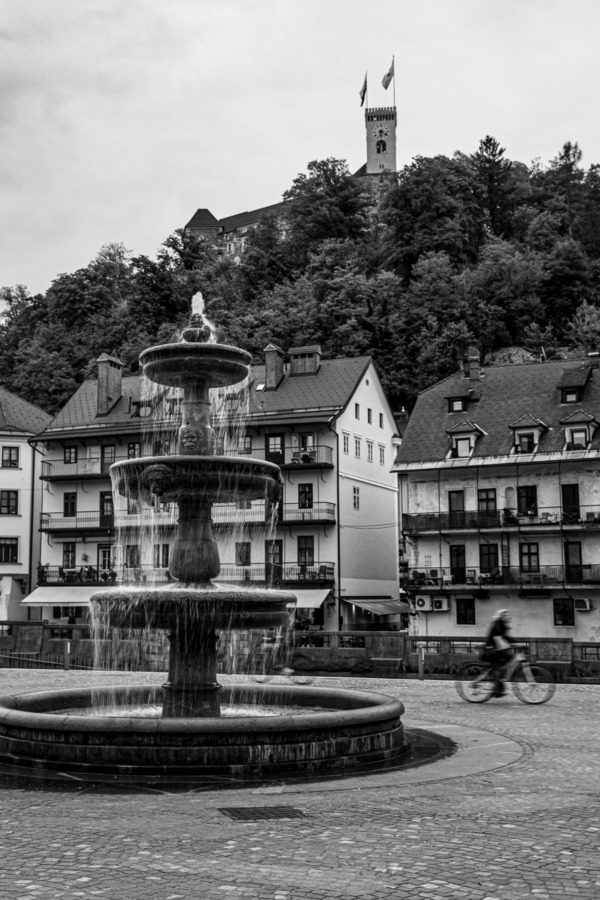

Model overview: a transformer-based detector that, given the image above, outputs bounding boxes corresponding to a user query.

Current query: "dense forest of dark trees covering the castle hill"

[0,137,600,412]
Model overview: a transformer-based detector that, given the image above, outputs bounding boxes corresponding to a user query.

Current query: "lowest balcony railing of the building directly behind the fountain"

[37,561,335,587]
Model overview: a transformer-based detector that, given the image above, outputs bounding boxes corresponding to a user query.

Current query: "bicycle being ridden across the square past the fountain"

[456,653,556,704]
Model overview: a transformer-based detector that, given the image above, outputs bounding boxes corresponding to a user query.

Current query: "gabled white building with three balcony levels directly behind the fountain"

[24,345,401,631]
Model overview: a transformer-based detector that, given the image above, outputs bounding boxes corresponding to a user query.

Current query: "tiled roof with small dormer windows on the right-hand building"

[396,359,600,467]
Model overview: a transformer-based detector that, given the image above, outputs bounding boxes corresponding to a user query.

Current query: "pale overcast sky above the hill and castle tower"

[0,0,600,292]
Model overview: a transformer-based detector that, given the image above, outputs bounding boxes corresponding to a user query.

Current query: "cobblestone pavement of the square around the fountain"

[0,670,600,900]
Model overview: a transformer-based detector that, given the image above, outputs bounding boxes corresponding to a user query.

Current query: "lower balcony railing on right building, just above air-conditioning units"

[401,563,600,593]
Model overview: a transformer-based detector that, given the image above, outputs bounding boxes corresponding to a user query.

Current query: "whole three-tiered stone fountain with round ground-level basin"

[0,298,406,783]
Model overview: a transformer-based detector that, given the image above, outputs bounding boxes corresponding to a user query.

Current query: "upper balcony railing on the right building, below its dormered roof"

[402,505,600,532]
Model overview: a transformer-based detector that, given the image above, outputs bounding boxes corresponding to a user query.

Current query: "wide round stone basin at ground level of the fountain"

[0,684,407,784]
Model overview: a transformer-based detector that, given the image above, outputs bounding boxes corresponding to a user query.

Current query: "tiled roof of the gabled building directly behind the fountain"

[36,356,371,435]
